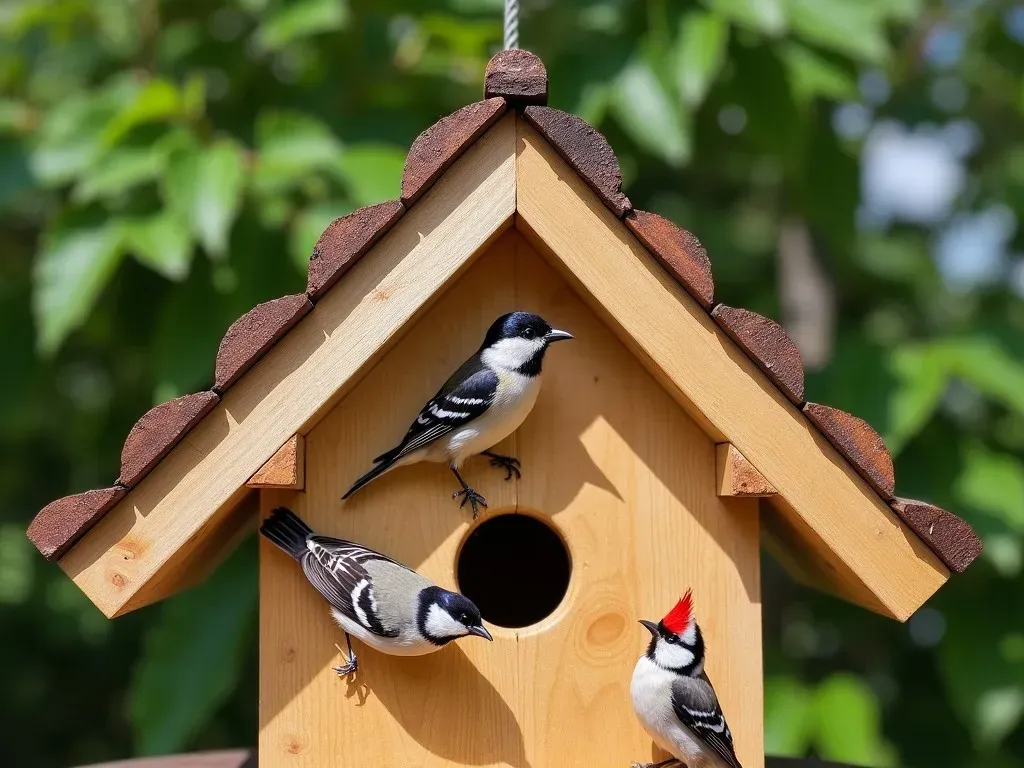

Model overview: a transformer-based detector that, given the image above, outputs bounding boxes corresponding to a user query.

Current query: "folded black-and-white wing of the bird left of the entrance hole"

[302,536,404,637]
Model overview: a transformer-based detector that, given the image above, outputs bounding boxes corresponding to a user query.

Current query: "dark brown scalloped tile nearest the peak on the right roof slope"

[522,106,633,218]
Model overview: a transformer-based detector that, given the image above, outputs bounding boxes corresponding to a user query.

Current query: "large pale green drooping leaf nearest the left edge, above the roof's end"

[32,223,124,355]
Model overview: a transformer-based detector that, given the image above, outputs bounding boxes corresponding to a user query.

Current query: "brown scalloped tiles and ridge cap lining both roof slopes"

[29,50,981,613]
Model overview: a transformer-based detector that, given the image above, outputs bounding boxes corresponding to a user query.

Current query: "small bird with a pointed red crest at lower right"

[630,590,740,768]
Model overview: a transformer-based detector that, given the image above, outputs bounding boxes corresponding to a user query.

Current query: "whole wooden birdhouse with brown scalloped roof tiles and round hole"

[29,50,981,768]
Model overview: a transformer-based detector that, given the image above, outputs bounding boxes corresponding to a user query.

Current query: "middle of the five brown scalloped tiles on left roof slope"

[213,293,313,394]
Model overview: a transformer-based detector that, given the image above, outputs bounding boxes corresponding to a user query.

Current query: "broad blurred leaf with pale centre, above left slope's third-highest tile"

[253,112,342,195]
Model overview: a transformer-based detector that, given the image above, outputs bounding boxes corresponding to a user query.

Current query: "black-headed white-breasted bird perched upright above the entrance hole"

[342,312,572,517]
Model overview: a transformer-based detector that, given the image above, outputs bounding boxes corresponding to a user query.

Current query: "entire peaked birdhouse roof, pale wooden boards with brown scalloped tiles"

[29,50,981,618]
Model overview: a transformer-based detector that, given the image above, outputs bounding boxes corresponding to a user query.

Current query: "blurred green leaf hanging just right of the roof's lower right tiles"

[884,346,949,456]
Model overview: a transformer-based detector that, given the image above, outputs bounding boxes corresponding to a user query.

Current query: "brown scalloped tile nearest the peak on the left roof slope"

[401,98,506,208]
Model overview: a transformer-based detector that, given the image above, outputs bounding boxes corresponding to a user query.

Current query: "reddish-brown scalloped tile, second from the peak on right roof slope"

[624,210,715,311]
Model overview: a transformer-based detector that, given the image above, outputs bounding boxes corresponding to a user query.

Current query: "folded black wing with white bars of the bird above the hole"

[377,355,498,461]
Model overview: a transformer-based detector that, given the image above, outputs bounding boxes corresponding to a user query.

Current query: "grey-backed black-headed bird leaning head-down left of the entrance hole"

[259,507,494,676]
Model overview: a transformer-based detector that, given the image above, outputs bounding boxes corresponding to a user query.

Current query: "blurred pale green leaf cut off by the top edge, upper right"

[784,0,889,63]
